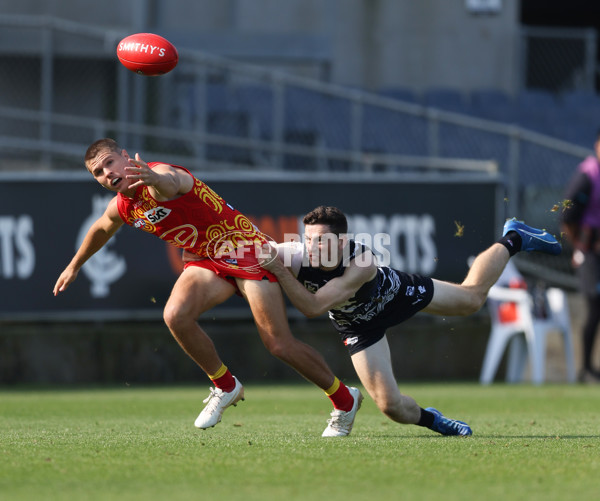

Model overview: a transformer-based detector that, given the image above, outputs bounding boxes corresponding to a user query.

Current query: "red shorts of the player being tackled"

[184,242,277,289]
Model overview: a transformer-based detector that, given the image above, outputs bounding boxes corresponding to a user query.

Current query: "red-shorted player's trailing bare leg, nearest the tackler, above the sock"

[237,279,334,390]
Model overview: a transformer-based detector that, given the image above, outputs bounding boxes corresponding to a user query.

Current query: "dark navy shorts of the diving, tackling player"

[332,270,433,355]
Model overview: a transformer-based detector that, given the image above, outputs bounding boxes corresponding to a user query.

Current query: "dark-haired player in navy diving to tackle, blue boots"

[260,206,561,435]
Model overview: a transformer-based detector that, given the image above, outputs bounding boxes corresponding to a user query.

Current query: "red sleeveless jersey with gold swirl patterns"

[117,162,265,259]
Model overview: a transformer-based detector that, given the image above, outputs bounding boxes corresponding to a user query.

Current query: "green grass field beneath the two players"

[0,383,600,501]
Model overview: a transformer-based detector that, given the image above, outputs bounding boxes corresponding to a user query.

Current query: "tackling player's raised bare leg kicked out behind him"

[423,243,510,315]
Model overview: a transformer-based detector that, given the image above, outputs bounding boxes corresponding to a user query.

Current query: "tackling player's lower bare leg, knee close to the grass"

[352,336,421,424]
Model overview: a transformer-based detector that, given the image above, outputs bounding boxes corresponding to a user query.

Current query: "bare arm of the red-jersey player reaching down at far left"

[53,197,123,296]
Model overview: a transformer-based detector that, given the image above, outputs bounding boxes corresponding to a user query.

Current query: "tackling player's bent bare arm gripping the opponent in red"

[261,244,377,318]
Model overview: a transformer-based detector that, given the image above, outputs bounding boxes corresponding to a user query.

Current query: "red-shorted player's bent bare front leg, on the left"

[164,267,235,374]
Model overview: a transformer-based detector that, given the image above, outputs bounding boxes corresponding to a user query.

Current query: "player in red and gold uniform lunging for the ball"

[54,138,362,436]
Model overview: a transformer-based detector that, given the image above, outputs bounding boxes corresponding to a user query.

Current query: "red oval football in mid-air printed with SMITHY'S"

[117,33,179,77]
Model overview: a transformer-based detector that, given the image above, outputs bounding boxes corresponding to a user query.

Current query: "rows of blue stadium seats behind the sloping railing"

[196,82,600,168]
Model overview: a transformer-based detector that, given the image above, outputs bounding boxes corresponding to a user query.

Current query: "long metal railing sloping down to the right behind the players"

[0,16,589,286]
